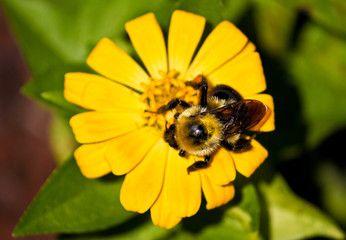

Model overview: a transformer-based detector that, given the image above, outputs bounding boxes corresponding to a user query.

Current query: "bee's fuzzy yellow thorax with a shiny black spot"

[175,115,221,156]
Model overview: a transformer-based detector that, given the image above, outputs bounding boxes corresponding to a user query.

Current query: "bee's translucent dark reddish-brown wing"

[208,100,268,136]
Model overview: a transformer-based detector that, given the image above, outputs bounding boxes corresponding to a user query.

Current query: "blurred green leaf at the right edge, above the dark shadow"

[288,24,346,147]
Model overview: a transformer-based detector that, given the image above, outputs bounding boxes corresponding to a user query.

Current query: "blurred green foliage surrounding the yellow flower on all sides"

[0,0,346,239]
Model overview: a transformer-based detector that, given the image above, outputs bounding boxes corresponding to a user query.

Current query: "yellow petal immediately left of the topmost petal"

[125,13,167,79]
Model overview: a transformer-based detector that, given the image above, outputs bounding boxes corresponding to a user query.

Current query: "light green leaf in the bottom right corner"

[260,176,345,240]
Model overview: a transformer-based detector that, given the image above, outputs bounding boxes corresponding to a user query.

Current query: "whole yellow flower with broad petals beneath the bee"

[64,10,274,228]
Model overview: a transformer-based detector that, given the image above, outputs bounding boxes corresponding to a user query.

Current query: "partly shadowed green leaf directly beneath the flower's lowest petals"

[61,184,260,240]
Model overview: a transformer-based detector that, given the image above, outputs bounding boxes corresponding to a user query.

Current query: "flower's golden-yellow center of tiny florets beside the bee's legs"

[141,70,198,130]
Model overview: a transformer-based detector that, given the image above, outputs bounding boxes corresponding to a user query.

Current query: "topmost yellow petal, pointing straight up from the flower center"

[168,10,205,76]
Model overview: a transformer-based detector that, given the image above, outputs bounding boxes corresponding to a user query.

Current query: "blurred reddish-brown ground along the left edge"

[0,9,55,240]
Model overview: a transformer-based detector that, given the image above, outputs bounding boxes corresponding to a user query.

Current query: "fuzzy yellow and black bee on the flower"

[156,75,268,173]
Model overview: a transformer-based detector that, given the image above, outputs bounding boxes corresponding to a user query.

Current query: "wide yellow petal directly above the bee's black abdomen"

[208,52,266,97]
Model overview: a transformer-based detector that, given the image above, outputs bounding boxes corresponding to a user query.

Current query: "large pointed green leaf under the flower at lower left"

[13,159,135,236]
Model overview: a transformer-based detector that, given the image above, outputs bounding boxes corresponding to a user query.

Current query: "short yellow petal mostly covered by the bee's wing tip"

[247,94,275,132]
